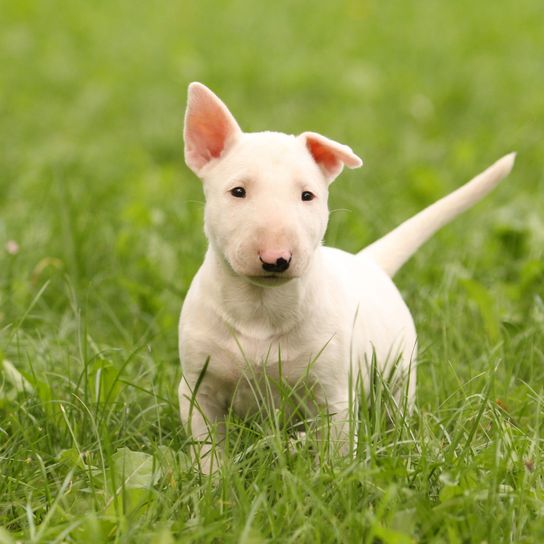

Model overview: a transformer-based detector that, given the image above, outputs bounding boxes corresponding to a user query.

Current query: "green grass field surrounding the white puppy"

[0,0,544,544]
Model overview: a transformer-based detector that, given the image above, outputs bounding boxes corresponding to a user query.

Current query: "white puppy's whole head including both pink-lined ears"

[184,83,362,285]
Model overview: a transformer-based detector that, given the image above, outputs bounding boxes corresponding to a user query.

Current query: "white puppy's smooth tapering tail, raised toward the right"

[359,153,516,277]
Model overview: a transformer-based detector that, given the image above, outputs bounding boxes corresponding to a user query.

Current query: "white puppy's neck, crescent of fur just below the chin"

[202,245,318,340]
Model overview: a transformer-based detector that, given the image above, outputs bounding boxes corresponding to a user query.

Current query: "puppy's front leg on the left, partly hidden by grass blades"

[179,377,226,474]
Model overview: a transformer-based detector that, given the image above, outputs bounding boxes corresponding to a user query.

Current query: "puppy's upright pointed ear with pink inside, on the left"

[183,82,242,175]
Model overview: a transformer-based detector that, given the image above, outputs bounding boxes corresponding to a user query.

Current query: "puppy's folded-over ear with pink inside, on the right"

[299,132,363,183]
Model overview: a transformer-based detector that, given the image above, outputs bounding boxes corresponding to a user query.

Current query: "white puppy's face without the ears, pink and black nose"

[203,133,328,285]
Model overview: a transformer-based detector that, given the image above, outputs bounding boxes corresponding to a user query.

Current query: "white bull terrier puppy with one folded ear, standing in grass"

[179,83,515,472]
